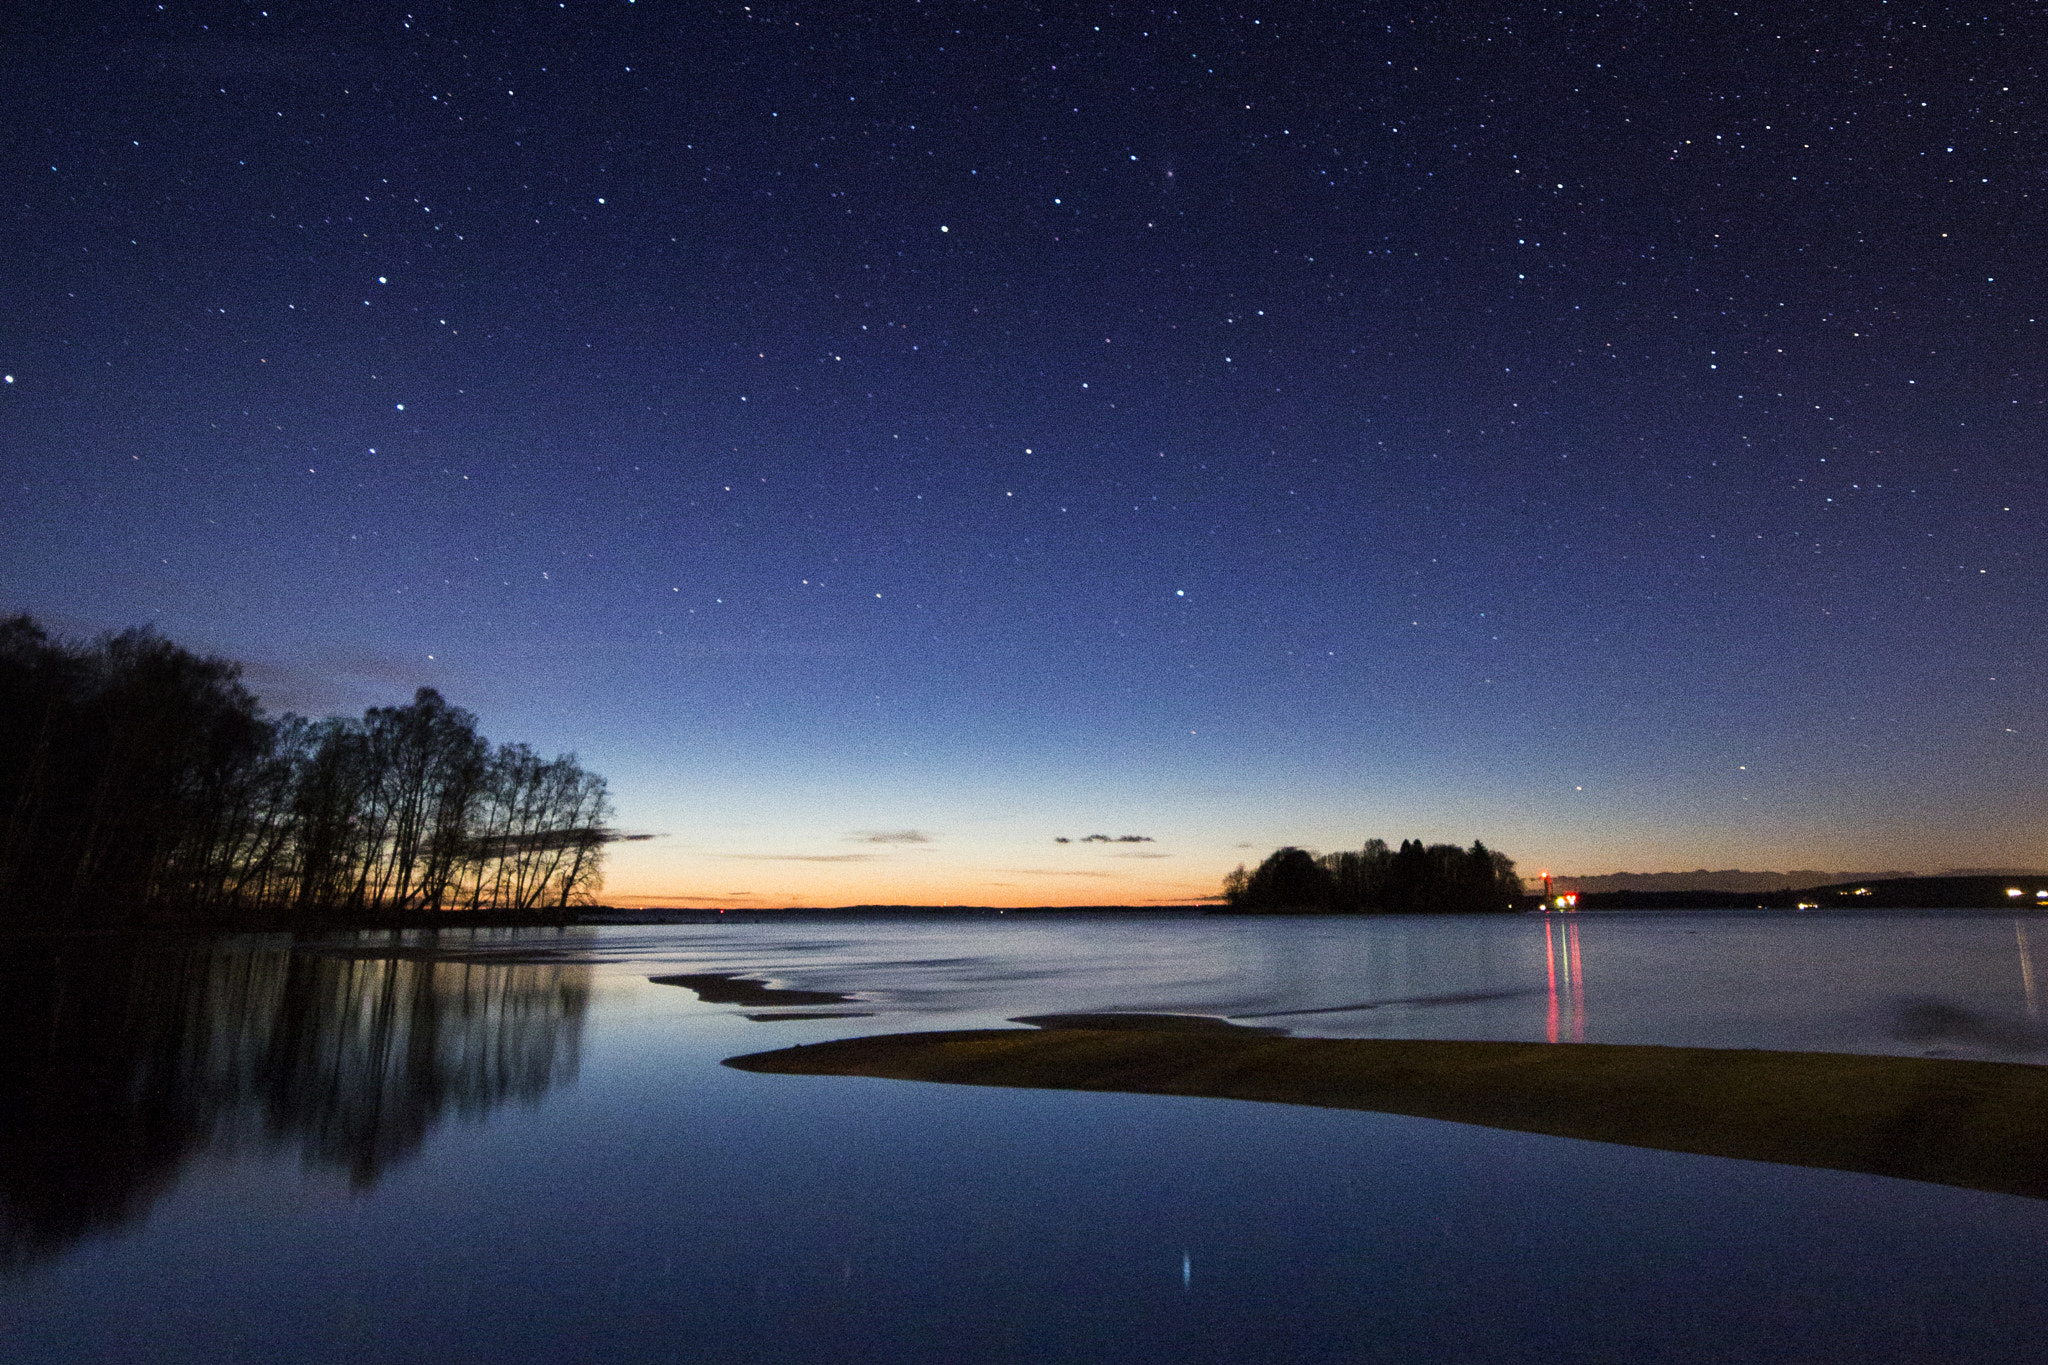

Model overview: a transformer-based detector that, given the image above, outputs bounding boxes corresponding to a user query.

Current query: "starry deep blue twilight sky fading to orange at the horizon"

[0,0,2048,905]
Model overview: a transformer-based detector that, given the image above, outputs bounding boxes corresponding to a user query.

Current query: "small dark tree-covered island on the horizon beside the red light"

[1223,839,1522,915]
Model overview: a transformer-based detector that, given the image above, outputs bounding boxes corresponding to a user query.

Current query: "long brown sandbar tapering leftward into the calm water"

[725,1031,2048,1199]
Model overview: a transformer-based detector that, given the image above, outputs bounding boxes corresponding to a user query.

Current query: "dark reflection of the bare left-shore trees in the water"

[0,939,590,1269]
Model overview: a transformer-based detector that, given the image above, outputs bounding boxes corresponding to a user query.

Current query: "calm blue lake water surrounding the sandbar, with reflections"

[0,913,2048,1365]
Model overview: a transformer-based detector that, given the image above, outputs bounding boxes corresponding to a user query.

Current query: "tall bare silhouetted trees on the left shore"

[0,616,616,925]
